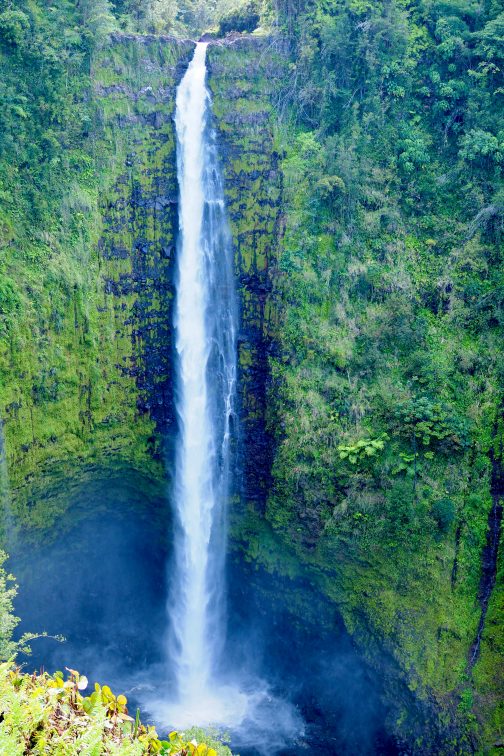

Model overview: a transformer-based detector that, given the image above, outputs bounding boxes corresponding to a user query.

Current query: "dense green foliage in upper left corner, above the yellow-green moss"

[0,2,93,338]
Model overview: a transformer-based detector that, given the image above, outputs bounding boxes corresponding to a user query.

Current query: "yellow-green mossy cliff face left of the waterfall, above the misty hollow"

[0,35,193,529]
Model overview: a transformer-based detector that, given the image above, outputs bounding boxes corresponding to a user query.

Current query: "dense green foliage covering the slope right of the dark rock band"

[258,0,504,747]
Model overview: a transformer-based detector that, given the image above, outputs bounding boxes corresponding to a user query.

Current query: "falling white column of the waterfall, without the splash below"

[168,43,237,714]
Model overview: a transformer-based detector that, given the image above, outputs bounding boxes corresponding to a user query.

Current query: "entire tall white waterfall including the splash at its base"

[146,42,303,756]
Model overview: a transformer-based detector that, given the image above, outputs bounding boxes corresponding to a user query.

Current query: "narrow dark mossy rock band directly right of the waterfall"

[208,37,285,511]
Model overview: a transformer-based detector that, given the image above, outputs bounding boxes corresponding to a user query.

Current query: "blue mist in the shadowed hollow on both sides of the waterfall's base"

[9,471,397,756]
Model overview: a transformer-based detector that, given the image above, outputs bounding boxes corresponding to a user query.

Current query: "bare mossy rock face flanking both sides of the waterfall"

[0,34,282,529]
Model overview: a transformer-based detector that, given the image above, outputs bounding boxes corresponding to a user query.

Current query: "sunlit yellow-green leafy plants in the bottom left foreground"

[0,662,231,756]
